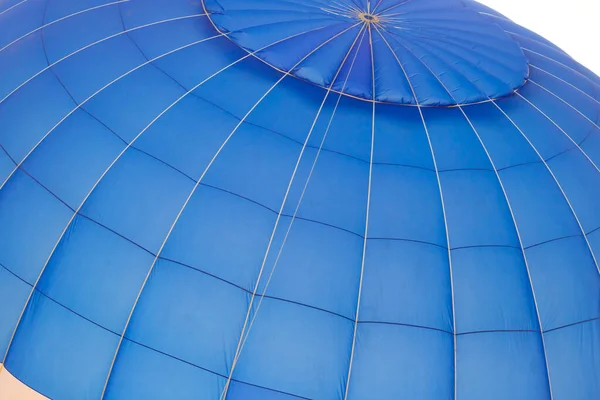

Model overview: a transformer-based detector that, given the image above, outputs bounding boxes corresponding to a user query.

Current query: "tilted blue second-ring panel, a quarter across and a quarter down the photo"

[85,61,185,142]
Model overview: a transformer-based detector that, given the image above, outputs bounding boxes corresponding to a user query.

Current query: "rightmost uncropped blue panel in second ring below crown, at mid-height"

[500,163,581,247]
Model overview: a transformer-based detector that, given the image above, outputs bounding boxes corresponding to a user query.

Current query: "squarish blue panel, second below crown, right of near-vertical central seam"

[369,165,447,247]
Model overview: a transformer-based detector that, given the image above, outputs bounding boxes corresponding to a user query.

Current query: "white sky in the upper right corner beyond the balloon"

[477,0,600,75]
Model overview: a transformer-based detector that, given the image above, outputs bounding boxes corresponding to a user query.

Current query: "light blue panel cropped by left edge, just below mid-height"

[0,171,73,284]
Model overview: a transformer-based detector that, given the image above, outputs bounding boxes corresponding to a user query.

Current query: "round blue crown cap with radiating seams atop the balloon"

[204,0,529,106]
